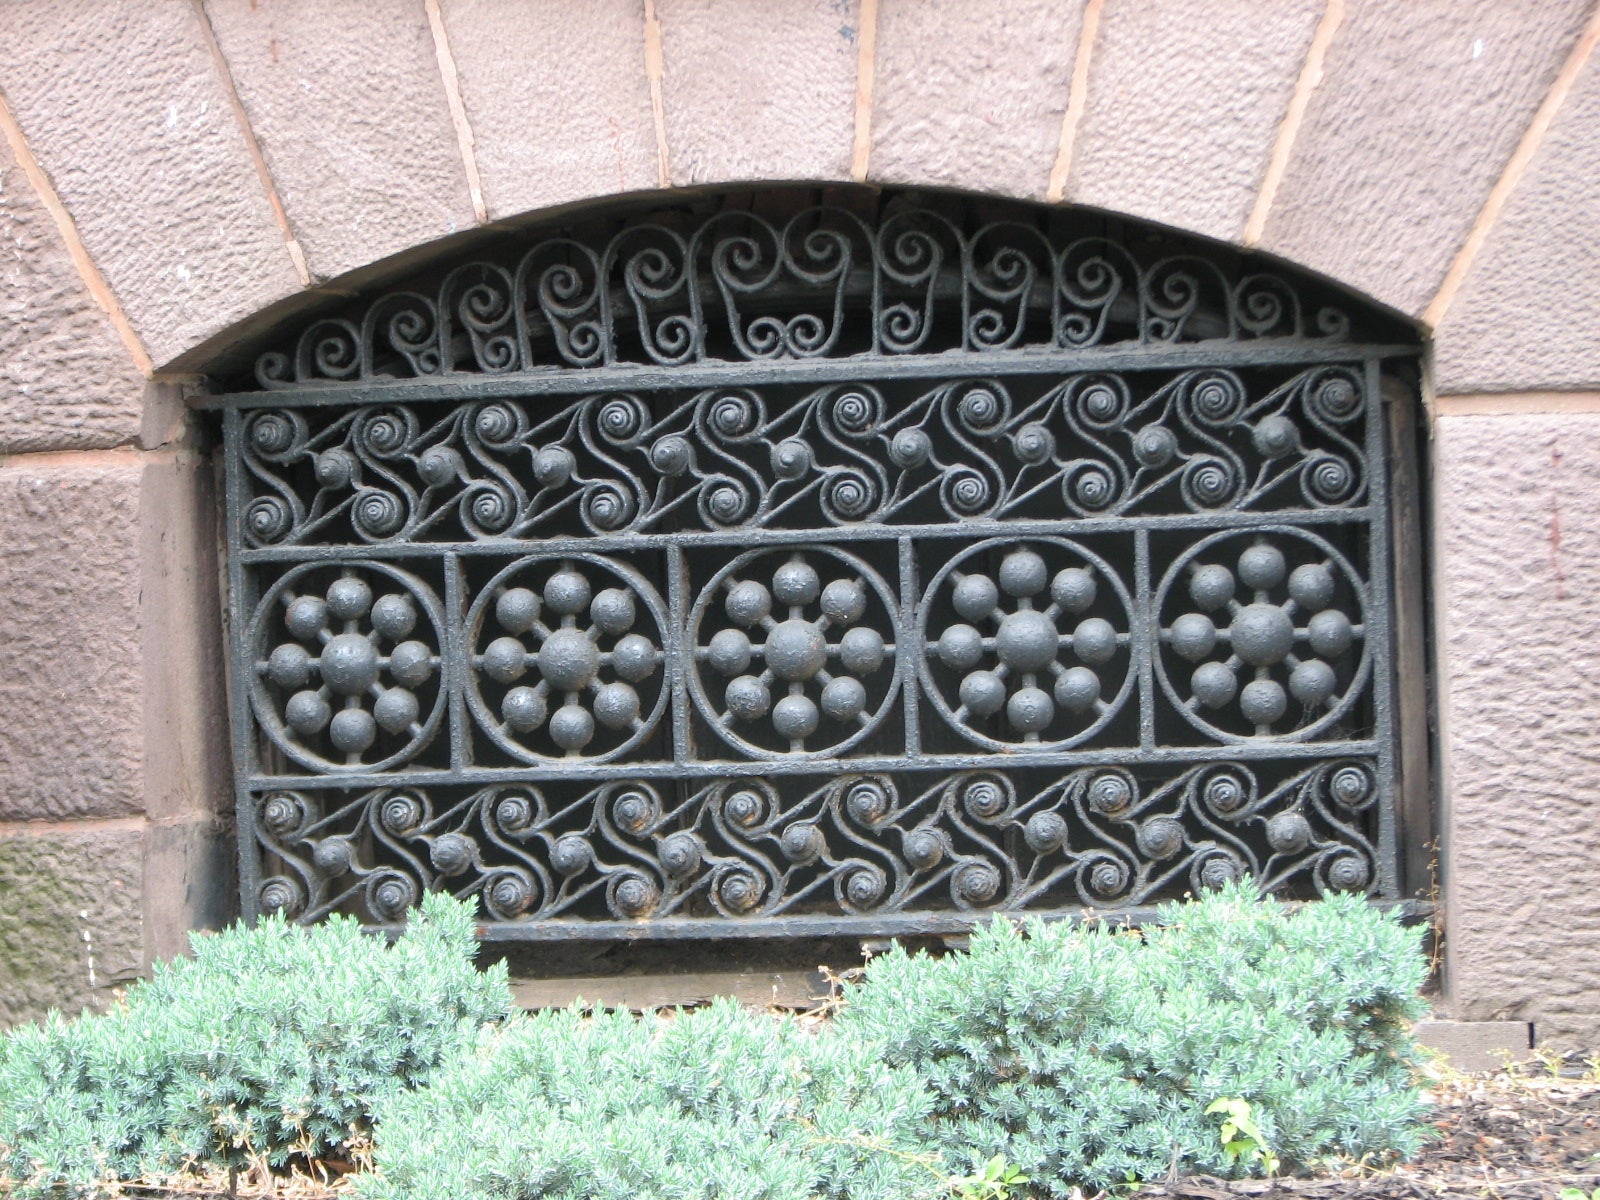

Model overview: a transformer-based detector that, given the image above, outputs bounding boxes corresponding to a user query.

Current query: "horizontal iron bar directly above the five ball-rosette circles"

[237,506,1373,563]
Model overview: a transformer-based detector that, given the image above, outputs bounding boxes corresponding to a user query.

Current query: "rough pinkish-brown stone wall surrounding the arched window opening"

[0,0,1600,1045]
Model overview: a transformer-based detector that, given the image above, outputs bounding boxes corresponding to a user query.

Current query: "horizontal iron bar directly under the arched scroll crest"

[195,338,1418,410]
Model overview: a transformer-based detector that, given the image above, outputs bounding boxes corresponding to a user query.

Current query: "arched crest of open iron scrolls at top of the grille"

[243,206,1369,389]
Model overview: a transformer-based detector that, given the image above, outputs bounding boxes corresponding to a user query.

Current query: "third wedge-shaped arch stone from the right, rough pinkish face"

[870,0,1083,198]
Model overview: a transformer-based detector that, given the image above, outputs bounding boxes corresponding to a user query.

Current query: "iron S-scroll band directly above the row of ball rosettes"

[242,366,1366,546]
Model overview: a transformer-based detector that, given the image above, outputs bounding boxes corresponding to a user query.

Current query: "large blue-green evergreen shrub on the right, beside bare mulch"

[837,888,1426,1197]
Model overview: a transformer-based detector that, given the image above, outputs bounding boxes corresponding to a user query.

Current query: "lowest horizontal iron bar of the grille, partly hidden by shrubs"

[366,898,1434,942]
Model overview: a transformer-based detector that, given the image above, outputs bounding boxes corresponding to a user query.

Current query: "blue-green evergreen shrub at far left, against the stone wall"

[0,896,512,1197]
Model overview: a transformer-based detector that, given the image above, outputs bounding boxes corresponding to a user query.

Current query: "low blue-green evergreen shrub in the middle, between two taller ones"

[362,1000,947,1200]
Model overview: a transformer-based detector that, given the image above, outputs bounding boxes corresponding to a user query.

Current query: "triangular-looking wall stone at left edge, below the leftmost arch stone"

[0,132,144,454]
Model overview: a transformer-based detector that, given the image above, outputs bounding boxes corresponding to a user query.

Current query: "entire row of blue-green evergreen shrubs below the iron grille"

[0,886,1426,1200]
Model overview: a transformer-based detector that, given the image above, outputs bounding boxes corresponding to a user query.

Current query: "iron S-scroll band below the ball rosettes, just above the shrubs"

[259,758,1378,922]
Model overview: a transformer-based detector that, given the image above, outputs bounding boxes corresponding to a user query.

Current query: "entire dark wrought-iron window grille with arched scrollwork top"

[213,190,1416,938]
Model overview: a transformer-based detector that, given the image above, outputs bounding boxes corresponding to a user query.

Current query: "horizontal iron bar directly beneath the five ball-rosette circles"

[243,738,1379,792]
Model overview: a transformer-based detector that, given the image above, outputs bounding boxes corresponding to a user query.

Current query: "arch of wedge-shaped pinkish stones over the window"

[3,0,1589,390]
